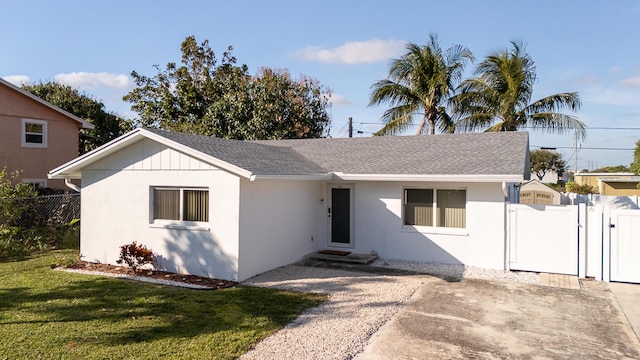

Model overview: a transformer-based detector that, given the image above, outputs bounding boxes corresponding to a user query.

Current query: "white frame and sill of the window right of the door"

[400,186,469,235]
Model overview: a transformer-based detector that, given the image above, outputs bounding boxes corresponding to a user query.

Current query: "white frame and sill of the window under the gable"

[149,186,211,231]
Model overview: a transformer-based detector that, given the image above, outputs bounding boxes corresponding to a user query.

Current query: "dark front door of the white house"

[327,185,353,247]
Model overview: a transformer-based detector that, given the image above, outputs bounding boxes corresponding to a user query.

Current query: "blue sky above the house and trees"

[0,0,640,169]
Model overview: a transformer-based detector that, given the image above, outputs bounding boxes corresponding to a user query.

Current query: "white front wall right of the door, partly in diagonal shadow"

[332,182,505,269]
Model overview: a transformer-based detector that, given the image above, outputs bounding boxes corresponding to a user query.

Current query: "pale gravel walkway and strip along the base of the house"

[241,260,538,359]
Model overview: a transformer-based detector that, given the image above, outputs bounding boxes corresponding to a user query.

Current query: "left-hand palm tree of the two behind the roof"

[369,34,473,135]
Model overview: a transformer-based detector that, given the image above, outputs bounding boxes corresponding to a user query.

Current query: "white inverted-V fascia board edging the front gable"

[47,128,252,179]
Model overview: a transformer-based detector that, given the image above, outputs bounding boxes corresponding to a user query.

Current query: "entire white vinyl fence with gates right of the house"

[507,203,640,283]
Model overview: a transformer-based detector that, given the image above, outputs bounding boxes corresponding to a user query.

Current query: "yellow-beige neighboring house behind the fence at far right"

[575,172,640,196]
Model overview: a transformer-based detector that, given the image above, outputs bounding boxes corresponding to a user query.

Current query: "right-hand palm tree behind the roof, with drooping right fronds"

[453,42,586,138]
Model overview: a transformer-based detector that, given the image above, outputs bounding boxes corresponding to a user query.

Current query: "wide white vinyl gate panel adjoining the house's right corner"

[507,204,579,275]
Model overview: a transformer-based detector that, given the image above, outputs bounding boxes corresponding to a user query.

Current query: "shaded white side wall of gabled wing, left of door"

[239,179,325,280]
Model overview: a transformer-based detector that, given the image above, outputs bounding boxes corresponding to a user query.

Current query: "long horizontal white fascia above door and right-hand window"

[334,172,524,182]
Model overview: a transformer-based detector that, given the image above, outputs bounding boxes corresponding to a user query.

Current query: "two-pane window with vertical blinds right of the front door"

[404,189,467,228]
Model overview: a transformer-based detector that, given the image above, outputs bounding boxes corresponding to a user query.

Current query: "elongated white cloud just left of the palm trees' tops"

[293,39,406,64]
